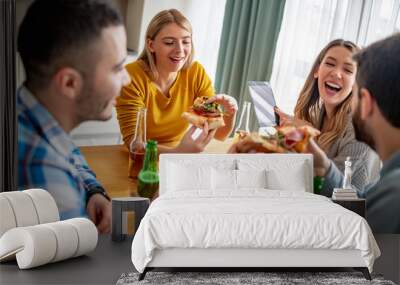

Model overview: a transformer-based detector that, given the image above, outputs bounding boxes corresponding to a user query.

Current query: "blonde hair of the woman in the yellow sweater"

[138,9,194,80]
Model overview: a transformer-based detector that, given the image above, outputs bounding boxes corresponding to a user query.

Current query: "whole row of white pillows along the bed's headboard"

[163,155,312,193]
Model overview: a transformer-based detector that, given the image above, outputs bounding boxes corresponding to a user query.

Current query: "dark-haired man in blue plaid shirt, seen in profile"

[17,0,129,232]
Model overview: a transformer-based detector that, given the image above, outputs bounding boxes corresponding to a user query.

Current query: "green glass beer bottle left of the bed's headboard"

[138,140,160,199]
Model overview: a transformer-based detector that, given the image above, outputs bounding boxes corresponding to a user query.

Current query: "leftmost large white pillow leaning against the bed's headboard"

[167,163,212,191]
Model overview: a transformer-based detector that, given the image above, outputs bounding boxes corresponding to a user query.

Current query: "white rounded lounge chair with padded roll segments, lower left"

[0,189,98,269]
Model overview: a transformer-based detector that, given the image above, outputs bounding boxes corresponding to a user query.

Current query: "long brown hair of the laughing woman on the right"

[294,39,360,151]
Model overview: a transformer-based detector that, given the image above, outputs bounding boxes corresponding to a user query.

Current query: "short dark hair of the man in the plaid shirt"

[17,0,123,88]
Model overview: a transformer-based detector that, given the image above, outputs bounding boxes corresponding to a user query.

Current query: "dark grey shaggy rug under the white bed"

[117,271,395,285]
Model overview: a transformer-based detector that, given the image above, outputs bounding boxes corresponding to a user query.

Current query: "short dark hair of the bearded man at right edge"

[354,33,400,128]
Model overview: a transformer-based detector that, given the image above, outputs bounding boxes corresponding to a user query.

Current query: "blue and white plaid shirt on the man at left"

[17,86,107,220]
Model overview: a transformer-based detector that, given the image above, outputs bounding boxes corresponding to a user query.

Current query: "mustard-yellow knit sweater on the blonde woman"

[116,61,215,147]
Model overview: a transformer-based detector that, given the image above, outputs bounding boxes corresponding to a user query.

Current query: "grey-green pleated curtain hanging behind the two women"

[215,0,285,131]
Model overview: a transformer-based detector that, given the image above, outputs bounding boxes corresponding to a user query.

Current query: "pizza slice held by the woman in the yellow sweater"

[182,96,225,130]
